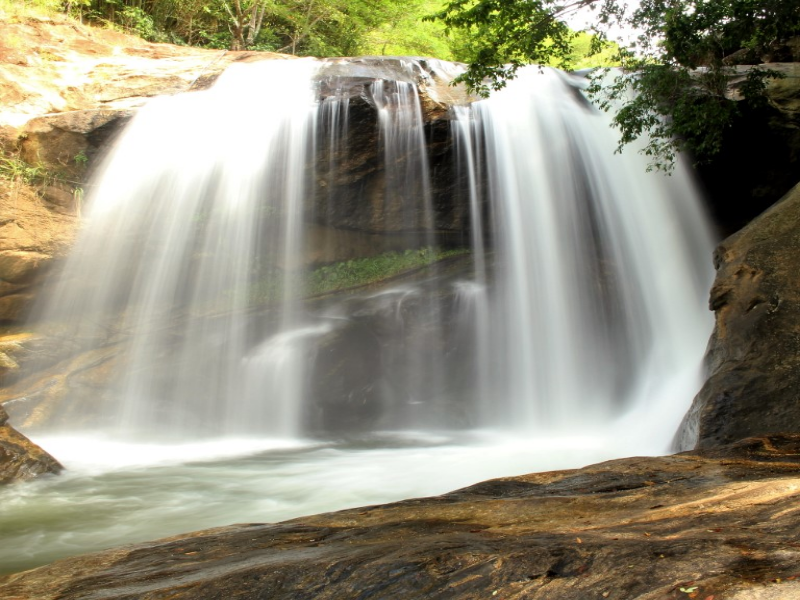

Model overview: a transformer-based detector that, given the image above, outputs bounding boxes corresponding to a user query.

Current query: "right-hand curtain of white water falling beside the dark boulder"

[460,70,709,436]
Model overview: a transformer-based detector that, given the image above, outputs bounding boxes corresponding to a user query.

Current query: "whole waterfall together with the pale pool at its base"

[0,59,711,571]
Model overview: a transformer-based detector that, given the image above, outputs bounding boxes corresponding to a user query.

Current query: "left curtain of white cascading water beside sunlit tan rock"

[29,61,318,438]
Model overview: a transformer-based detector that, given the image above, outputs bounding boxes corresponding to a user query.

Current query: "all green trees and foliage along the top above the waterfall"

[0,0,800,176]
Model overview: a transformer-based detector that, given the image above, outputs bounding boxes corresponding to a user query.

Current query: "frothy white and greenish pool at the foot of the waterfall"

[0,431,676,573]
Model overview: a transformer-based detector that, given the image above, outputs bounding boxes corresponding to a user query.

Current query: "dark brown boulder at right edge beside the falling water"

[678,185,800,448]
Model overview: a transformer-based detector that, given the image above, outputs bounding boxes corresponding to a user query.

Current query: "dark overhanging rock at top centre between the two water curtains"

[307,66,469,239]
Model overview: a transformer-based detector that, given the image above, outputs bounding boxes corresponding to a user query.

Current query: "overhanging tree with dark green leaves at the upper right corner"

[433,0,800,170]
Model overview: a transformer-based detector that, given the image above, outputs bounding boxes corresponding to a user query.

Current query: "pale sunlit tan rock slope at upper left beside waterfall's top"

[0,16,284,132]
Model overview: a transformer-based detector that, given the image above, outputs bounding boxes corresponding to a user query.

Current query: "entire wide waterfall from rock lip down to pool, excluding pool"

[23,59,710,451]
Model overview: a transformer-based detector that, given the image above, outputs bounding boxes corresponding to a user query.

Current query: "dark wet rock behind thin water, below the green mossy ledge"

[307,256,479,433]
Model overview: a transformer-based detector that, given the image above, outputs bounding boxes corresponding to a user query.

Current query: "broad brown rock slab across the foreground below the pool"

[0,435,800,600]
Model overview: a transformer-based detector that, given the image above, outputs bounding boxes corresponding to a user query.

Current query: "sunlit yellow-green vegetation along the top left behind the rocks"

[0,0,614,68]
